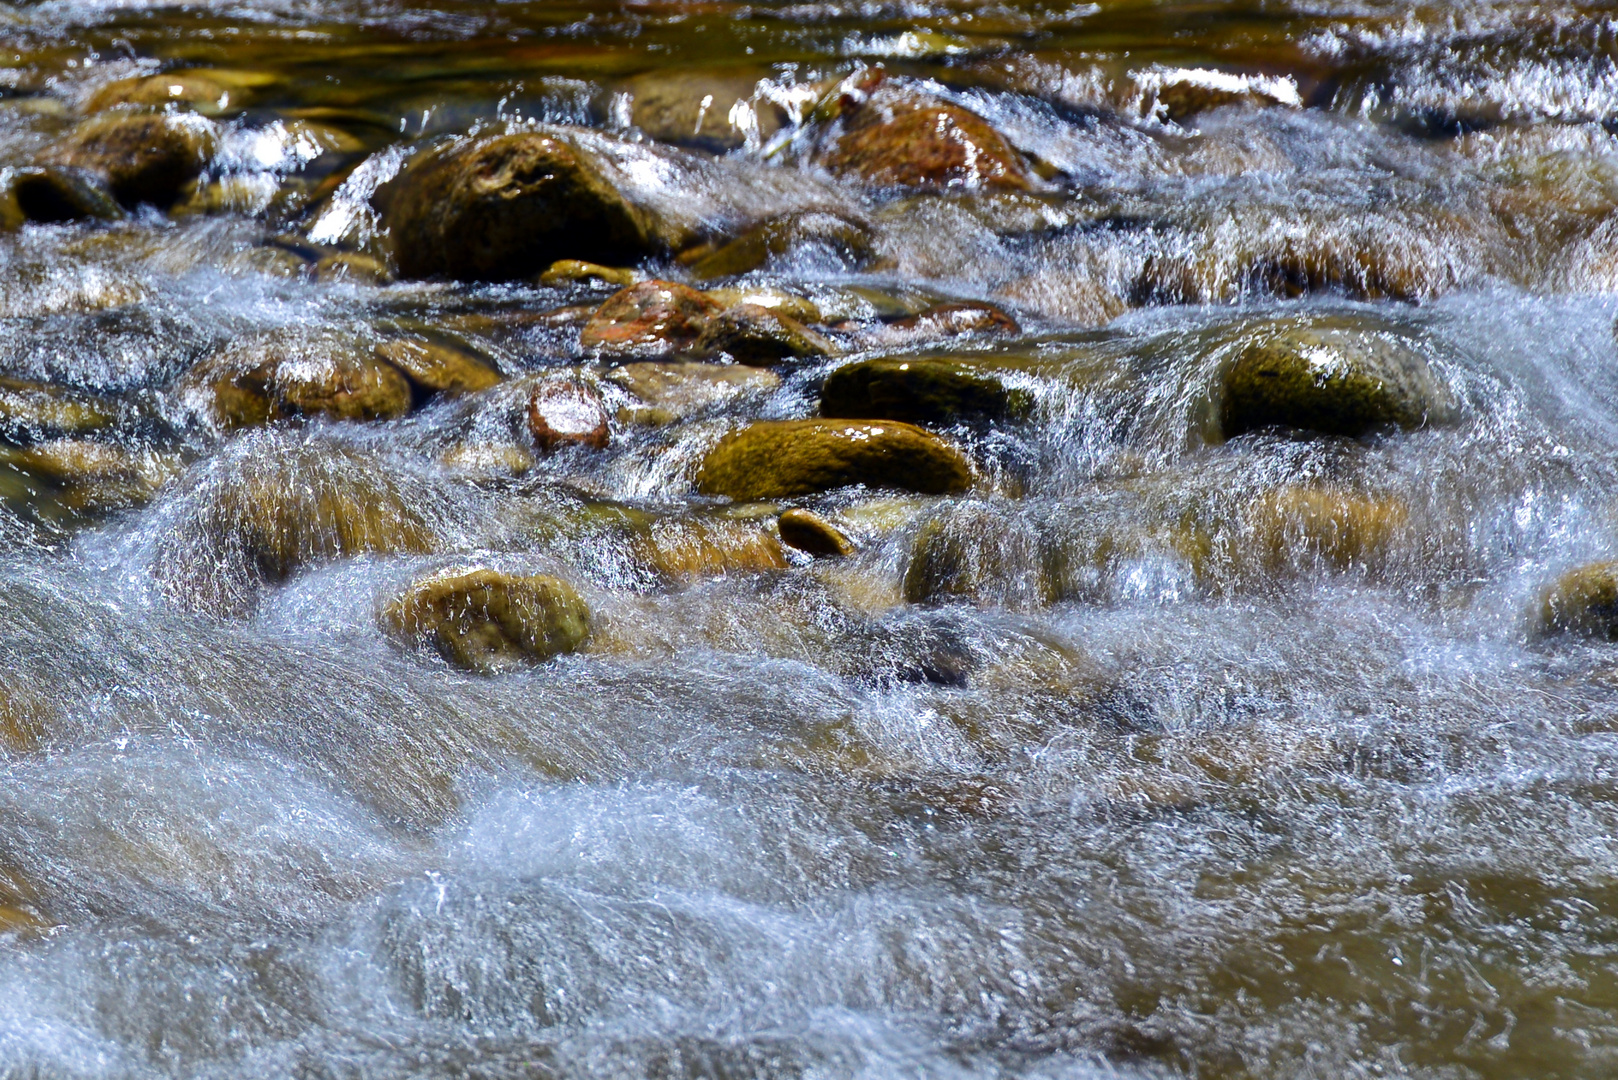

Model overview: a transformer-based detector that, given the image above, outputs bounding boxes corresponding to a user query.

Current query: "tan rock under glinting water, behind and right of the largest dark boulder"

[623,70,786,154]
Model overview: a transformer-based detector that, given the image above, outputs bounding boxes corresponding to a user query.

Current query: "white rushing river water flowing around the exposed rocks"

[0,0,1618,1080]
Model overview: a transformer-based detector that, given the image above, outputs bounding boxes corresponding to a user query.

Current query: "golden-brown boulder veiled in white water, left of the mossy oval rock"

[154,431,442,615]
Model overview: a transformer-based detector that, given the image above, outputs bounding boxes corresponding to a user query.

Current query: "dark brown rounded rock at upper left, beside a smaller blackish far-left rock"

[42,110,218,207]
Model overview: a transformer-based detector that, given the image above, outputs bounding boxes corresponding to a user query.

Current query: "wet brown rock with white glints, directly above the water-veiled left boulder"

[180,330,411,427]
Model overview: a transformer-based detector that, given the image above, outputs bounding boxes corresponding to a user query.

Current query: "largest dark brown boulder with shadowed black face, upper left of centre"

[379,131,665,280]
